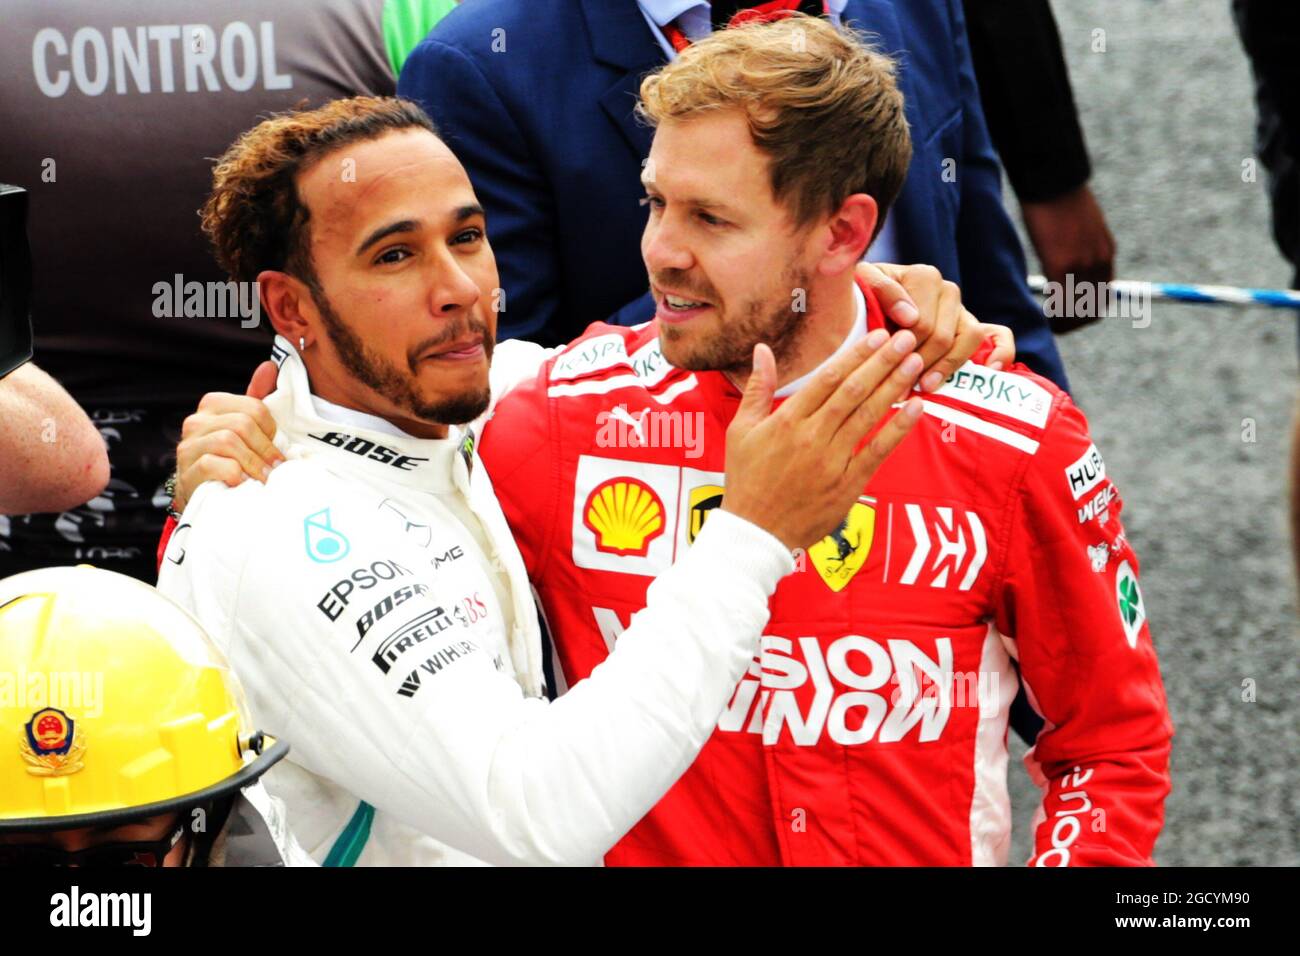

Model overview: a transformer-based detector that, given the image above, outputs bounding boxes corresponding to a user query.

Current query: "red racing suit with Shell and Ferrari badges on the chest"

[480,282,1173,866]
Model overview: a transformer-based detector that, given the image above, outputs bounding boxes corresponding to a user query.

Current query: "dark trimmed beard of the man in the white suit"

[312,291,494,425]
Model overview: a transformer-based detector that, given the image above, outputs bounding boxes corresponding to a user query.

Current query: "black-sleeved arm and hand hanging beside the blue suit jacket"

[963,0,1115,334]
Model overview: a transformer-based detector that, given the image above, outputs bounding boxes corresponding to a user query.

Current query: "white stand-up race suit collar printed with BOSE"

[267,336,475,498]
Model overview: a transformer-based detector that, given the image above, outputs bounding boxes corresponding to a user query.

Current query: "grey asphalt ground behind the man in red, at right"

[1008,0,1300,866]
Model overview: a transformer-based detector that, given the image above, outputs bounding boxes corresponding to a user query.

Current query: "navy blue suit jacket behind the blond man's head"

[398,0,1067,388]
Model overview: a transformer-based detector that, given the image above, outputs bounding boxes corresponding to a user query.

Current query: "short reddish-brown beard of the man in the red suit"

[657,265,811,377]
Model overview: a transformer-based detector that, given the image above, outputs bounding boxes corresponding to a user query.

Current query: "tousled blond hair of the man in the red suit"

[637,13,911,238]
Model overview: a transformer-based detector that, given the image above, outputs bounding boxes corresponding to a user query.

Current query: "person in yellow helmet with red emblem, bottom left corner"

[0,567,311,868]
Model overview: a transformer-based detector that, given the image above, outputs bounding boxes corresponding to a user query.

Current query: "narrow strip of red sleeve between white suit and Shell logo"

[478,363,559,584]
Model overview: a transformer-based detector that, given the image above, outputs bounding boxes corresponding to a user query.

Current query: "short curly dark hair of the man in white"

[199,96,438,295]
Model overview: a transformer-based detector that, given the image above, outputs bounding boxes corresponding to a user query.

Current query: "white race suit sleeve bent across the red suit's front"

[176,480,793,864]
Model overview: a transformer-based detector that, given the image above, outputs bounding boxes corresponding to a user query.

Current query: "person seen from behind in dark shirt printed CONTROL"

[0,0,454,581]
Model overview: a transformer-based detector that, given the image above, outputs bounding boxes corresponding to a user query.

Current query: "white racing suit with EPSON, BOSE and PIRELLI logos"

[159,339,793,865]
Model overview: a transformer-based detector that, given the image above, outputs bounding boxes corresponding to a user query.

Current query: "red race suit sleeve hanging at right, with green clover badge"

[997,397,1174,866]
